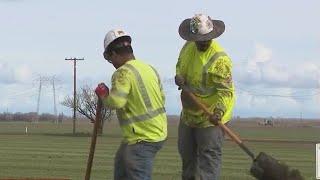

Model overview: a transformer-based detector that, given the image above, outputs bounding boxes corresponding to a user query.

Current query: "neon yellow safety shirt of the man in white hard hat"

[104,60,167,144]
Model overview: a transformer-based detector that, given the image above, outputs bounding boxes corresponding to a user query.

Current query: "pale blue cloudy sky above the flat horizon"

[0,0,320,118]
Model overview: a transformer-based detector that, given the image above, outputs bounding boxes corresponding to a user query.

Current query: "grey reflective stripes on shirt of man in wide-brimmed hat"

[189,52,227,95]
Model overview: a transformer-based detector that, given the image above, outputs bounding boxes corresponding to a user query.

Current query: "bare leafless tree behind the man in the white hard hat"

[61,85,112,134]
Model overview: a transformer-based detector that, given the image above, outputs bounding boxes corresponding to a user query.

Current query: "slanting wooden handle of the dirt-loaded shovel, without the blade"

[181,86,255,160]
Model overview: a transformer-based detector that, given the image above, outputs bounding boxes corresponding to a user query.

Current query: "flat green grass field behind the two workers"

[0,121,320,180]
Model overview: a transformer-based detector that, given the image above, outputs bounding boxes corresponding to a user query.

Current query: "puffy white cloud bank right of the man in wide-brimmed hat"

[234,44,320,88]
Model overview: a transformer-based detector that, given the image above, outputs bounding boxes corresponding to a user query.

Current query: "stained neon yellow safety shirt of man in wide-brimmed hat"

[176,40,235,127]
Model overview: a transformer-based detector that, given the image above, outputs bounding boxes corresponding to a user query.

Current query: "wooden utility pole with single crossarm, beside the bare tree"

[64,58,84,134]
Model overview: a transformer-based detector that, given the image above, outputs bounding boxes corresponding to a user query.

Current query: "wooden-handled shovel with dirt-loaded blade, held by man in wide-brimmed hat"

[181,86,303,180]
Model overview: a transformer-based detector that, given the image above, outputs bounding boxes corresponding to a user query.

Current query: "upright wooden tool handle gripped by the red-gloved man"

[85,98,102,180]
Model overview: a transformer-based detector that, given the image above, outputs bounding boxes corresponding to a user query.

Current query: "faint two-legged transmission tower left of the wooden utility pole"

[35,76,58,123]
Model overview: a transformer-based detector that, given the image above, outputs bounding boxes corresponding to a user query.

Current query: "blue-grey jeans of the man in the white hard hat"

[114,141,164,180]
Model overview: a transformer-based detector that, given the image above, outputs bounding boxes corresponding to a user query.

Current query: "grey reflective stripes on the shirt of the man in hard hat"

[117,64,166,126]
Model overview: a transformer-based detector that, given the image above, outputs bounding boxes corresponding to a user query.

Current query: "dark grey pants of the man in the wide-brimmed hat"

[178,121,224,180]
